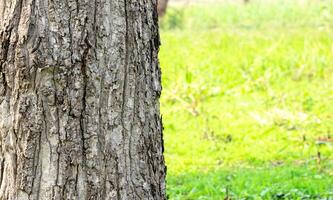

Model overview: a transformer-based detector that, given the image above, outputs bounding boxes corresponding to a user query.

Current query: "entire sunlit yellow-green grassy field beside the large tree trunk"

[160,1,333,200]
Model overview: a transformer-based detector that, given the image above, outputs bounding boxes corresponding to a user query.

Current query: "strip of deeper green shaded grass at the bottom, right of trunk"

[168,166,333,200]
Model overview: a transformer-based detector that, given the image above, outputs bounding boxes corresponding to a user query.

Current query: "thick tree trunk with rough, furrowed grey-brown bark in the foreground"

[0,0,166,200]
